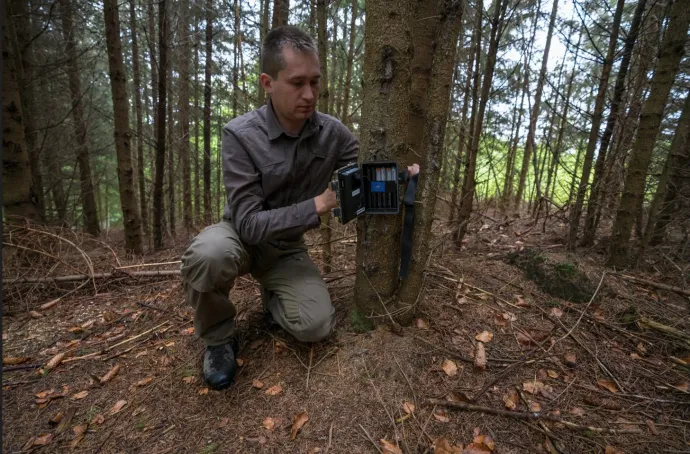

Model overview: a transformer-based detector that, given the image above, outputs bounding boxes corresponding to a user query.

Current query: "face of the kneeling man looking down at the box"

[261,46,321,123]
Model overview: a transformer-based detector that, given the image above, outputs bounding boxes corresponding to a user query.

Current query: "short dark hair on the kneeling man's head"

[261,25,319,79]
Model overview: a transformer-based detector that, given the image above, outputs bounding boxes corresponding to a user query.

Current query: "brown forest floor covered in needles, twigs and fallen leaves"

[2,203,690,454]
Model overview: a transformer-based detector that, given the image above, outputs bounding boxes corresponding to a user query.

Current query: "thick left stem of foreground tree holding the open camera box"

[355,0,415,316]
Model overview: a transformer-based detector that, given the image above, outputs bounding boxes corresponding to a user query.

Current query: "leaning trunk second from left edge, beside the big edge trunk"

[60,0,101,236]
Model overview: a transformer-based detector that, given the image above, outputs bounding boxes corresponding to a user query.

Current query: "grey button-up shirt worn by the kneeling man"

[222,102,359,245]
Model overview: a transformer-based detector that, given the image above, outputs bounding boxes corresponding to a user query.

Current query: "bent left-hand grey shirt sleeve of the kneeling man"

[222,127,320,245]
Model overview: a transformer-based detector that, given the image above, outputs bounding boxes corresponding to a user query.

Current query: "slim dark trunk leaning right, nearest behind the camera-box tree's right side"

[455,0,508,244]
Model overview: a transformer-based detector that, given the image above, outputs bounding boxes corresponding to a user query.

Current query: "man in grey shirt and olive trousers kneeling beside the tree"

[181,26,418,389]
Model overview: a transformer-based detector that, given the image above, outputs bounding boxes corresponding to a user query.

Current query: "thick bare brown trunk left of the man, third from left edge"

[103,0,143,254]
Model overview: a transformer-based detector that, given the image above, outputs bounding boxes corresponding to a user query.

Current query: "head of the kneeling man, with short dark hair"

[261,25,321,128]
